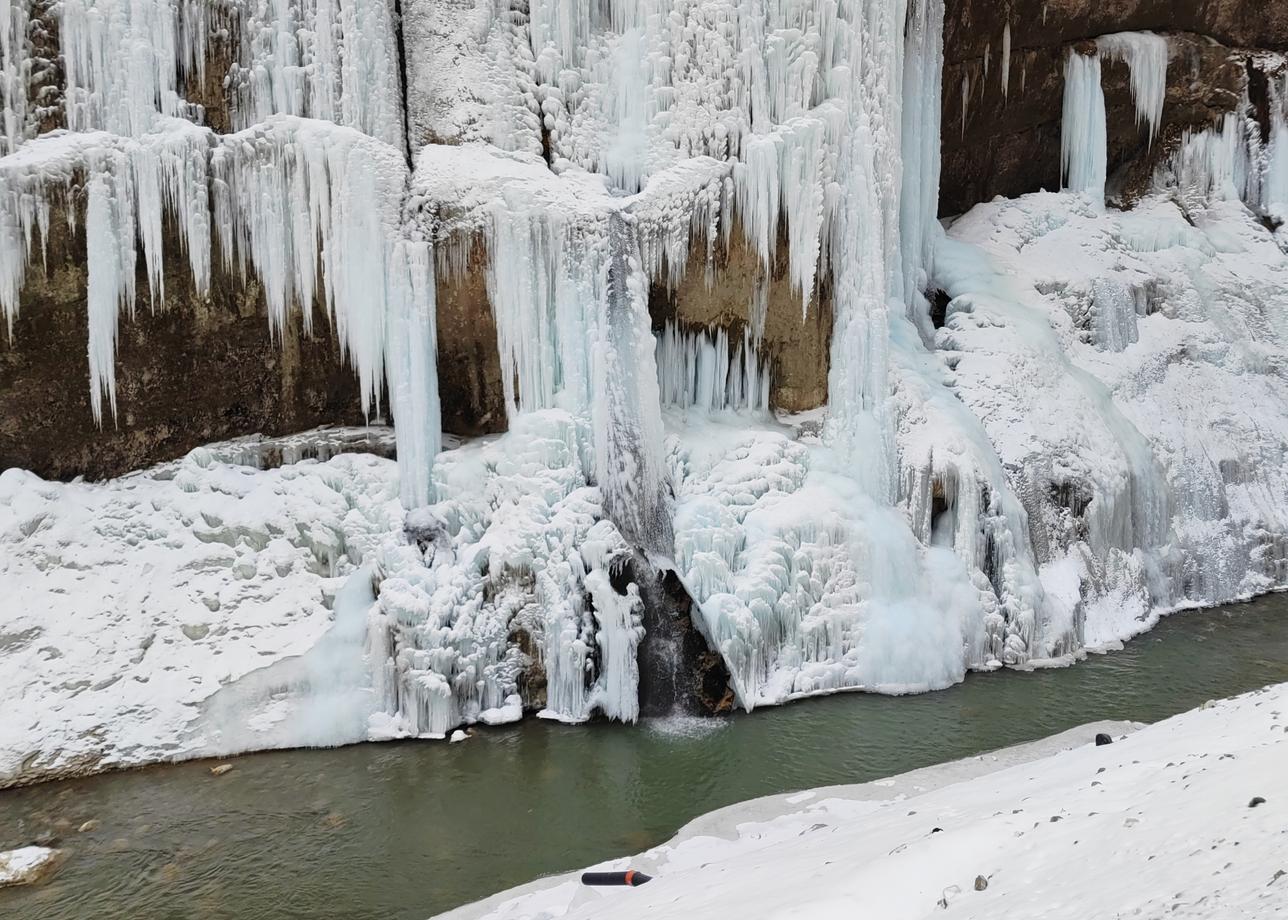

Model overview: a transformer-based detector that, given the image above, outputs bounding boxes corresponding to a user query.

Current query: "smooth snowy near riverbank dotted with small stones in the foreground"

[439,684,1288,920]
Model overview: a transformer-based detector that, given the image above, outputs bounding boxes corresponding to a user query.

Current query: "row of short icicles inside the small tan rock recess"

[657,322,772,414]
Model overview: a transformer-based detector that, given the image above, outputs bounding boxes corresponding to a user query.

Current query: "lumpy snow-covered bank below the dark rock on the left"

[0,442,402,786]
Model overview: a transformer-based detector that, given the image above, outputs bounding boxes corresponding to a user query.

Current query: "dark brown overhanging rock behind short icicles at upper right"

[939,0,1288,215]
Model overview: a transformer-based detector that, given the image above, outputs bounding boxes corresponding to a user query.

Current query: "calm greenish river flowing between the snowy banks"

[0,595,1288,920]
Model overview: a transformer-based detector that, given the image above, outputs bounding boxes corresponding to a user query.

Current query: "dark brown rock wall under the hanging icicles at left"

[0,197,363,478]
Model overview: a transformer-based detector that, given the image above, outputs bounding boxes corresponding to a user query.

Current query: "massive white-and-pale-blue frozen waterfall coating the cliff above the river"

[0,0,1288,760]
